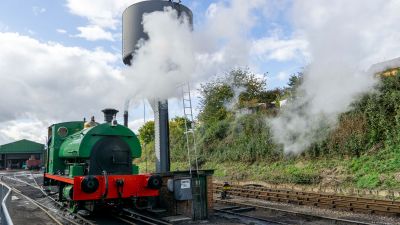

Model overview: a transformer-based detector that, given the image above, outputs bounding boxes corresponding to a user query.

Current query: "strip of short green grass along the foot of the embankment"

[139,149,400,191]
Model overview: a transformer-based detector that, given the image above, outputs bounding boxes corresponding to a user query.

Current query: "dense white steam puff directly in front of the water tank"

[125,8,195,98]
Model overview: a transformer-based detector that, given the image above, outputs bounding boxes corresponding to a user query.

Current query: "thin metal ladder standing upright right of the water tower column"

[182,82,199,174]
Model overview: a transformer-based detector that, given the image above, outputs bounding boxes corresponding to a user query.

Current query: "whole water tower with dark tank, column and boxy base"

[122,0,214,220]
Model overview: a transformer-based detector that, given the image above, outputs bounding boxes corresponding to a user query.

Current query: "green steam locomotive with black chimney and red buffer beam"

[44,109,162,212]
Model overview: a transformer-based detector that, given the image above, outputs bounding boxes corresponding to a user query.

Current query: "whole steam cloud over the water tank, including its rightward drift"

[124,0,266,100]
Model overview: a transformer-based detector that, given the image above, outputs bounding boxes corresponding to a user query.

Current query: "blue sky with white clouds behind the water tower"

[0,0,310,144]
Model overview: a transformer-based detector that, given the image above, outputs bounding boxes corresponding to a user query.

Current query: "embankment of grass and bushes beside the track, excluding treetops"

[140,69,400,191]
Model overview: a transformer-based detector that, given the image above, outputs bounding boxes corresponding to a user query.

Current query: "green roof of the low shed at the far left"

[0,139,44,154]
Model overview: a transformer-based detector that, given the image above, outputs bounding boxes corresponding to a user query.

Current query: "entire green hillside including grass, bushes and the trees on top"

[139,69,400,190]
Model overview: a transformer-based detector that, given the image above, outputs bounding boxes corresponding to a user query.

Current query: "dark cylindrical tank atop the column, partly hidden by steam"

[122,0,193,65]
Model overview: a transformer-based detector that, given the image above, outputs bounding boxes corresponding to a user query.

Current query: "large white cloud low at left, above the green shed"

[0,33,126,144]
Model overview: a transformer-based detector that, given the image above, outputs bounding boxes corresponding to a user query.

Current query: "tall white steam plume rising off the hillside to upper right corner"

[272,0,400,153]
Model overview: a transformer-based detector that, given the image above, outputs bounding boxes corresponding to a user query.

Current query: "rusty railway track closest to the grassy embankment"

[214,183,400,216]
